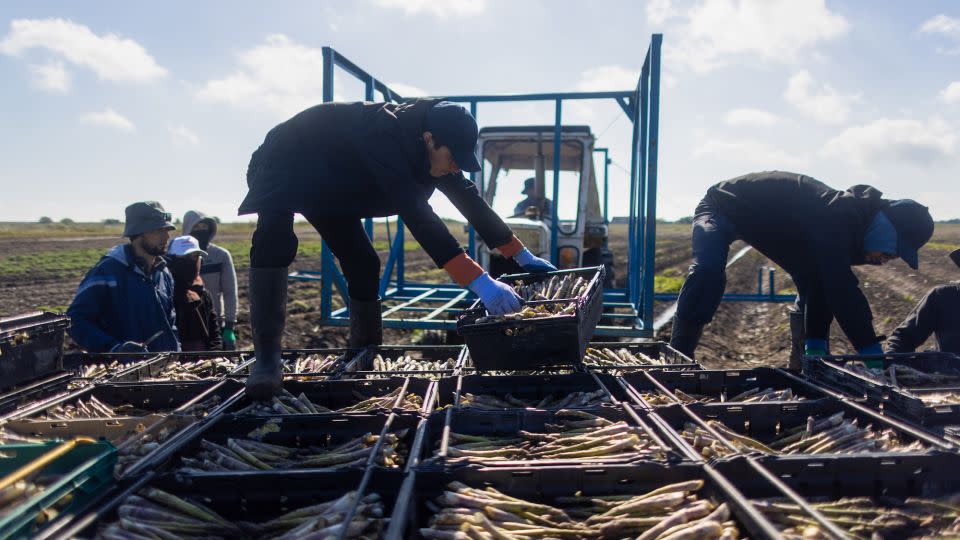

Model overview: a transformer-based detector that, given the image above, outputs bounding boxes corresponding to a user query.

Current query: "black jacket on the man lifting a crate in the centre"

[239,100,513,266]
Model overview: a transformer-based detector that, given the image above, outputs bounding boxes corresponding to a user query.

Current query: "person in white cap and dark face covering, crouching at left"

[167,235,223,351]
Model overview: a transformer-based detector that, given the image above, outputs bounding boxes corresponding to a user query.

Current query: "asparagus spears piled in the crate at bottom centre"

[420,480,740,540]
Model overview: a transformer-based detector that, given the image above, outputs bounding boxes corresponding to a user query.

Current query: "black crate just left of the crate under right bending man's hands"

[620,368,836,407]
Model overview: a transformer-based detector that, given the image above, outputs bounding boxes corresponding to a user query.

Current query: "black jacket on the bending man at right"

[707,171,889,349]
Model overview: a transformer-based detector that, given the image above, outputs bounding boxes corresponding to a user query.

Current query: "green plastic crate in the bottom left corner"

[0,441,117,540]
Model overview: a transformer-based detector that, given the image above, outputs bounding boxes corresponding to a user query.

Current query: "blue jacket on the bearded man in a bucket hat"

[67,244,180,352]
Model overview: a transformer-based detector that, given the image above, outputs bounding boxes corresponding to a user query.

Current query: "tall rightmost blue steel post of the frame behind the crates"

[643,34,663,334]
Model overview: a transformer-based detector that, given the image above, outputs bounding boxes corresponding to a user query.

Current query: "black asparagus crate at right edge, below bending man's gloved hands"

[805,352,960,425]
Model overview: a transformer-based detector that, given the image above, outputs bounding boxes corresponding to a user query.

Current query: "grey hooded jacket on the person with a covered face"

[183,210,237,328]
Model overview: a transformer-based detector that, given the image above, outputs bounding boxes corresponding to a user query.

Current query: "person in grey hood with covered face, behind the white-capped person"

[183,210,237,350]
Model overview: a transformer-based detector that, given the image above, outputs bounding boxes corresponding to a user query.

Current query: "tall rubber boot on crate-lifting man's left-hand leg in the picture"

[247,267,287,400]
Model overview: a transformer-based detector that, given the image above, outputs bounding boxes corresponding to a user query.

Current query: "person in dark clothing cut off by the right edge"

[887,249,960,353]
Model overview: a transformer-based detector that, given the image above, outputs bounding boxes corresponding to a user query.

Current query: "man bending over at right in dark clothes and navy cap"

[670,171,933,368]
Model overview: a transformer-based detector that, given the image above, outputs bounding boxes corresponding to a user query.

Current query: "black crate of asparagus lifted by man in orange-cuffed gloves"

[457,266,604,370]
